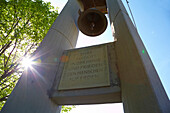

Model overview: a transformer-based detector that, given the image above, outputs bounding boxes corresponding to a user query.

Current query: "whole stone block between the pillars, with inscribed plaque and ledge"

[49,43,121,105]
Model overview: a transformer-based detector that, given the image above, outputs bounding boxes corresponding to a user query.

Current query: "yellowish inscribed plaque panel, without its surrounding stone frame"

[58,45,110,90]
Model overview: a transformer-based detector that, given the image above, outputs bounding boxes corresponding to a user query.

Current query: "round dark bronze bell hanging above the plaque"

[78,9,107,36]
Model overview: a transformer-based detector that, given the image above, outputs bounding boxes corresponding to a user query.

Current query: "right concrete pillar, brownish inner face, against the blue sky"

[106,0,170,113]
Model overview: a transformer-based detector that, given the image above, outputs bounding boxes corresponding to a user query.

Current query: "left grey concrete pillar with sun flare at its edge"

[1,0,79,113]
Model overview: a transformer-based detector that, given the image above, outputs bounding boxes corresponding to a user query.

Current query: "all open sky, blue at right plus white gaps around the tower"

[45,0,170,113]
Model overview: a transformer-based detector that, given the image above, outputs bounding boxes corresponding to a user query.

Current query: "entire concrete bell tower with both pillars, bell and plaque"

[1,0,170,113]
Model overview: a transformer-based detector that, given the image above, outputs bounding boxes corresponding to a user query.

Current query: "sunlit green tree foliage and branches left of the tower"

[0,0,58,109]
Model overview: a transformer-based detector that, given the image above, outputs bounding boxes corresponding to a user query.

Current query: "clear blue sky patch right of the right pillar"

[123,0,170,98]
